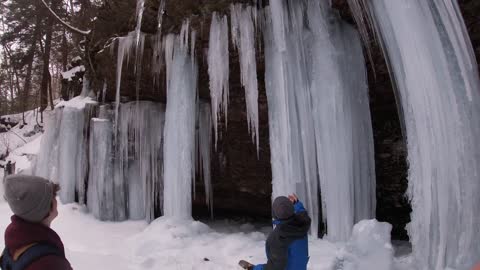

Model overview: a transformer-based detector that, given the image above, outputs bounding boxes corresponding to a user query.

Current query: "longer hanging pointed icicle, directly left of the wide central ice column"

[230,4,260,155]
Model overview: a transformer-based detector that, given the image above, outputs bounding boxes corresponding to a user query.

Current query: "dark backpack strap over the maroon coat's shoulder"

[1,243,65,270]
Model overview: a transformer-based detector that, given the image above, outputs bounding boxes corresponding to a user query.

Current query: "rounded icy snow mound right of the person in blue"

[333,220,394,270]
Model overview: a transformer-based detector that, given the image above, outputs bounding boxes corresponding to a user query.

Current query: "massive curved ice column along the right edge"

[369,0,480,270]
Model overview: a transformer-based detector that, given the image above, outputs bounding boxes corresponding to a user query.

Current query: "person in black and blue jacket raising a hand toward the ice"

[253,195,311,270]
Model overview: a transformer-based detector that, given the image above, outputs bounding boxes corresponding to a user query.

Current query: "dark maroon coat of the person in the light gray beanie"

[1,216,72,270]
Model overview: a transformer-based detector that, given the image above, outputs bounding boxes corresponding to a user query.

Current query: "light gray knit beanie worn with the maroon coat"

[4,175,54,223]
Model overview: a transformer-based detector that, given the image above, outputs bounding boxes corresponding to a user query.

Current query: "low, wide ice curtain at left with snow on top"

[34,101,165,221]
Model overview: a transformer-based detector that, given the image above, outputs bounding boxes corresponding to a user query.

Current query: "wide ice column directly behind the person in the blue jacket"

[265,0,375,241]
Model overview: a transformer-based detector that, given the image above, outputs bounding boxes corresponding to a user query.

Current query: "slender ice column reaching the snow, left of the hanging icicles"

[164,22,198,218]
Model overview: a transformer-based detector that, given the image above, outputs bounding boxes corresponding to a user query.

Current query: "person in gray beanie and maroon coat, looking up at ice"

[0,175,72,270]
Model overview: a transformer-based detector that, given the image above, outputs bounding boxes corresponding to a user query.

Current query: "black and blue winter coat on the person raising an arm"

[254,202,311,270]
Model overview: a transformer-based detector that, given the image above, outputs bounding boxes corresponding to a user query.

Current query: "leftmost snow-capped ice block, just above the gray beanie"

[33,97,96,203]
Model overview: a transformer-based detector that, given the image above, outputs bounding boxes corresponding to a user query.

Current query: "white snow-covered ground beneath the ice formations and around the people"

[0,105,412,270]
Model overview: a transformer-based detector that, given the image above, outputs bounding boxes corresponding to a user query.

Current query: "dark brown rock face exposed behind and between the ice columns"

[88,0,480,239]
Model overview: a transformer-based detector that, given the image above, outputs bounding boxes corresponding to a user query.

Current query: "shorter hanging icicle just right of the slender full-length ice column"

[208,13,230,146]
